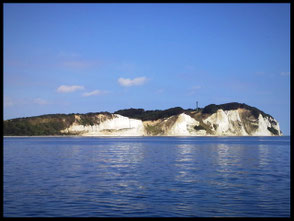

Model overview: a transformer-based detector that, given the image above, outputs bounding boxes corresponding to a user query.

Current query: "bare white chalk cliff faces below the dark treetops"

[61,108,282,136]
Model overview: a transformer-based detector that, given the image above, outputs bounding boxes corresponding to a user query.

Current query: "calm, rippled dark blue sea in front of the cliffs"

[3,137,290,217]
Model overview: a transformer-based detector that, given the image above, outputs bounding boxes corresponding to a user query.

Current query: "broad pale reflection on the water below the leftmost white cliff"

[97,143,146,211]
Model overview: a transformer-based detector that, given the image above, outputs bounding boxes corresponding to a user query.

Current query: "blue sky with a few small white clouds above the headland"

[3,3,290,134]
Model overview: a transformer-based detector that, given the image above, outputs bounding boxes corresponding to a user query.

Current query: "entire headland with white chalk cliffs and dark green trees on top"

[4,102,282,136]
